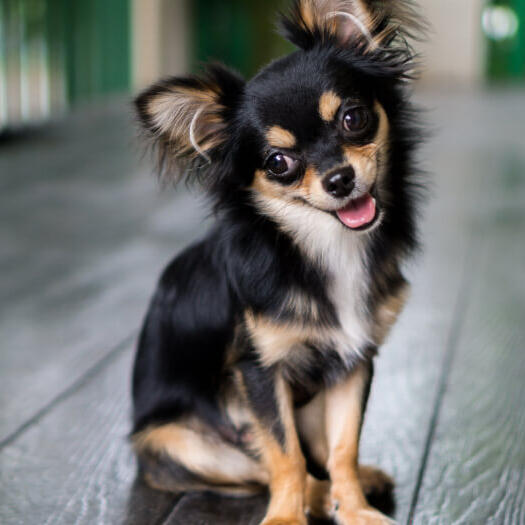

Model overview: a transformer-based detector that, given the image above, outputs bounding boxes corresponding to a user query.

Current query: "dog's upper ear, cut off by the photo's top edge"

[281,0,425,50]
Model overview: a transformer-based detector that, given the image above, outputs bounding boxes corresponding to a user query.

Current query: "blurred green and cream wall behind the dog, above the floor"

[0,0,525,129]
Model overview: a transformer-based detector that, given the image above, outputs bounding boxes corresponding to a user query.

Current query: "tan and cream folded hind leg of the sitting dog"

[133,422,268,495]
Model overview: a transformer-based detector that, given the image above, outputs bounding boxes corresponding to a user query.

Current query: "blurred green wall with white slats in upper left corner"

[0,0,131,128]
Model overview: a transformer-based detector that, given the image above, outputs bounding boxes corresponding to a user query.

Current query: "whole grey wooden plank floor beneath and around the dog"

[0,91,525,525]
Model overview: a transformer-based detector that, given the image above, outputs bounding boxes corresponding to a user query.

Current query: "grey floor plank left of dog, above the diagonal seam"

[0,102,205,446]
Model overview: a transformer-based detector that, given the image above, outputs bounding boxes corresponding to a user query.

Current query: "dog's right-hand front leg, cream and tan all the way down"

[326,363,392,525]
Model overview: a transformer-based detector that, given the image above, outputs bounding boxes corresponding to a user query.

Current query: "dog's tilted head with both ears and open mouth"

[137,0,421,231]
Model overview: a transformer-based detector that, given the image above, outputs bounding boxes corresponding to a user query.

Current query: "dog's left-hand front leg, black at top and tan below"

[241,362,306,525]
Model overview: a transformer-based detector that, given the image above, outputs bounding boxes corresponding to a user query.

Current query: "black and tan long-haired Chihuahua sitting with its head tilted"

[132,0,423,525]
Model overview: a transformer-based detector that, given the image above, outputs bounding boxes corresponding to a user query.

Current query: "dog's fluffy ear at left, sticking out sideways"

[135,65,244,177]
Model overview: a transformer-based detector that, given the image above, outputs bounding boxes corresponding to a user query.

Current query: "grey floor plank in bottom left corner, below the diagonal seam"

[0,346,178,525]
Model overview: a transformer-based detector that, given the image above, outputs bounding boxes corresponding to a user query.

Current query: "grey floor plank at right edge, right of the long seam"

[414,151,525,525]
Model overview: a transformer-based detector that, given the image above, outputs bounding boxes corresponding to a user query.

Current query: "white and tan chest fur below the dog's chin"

[247,205,372,375]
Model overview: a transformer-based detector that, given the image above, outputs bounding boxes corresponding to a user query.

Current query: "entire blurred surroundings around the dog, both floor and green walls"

[0,0,525,525]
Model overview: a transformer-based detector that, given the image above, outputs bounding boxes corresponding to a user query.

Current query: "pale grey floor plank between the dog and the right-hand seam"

[361,89,488,523]
